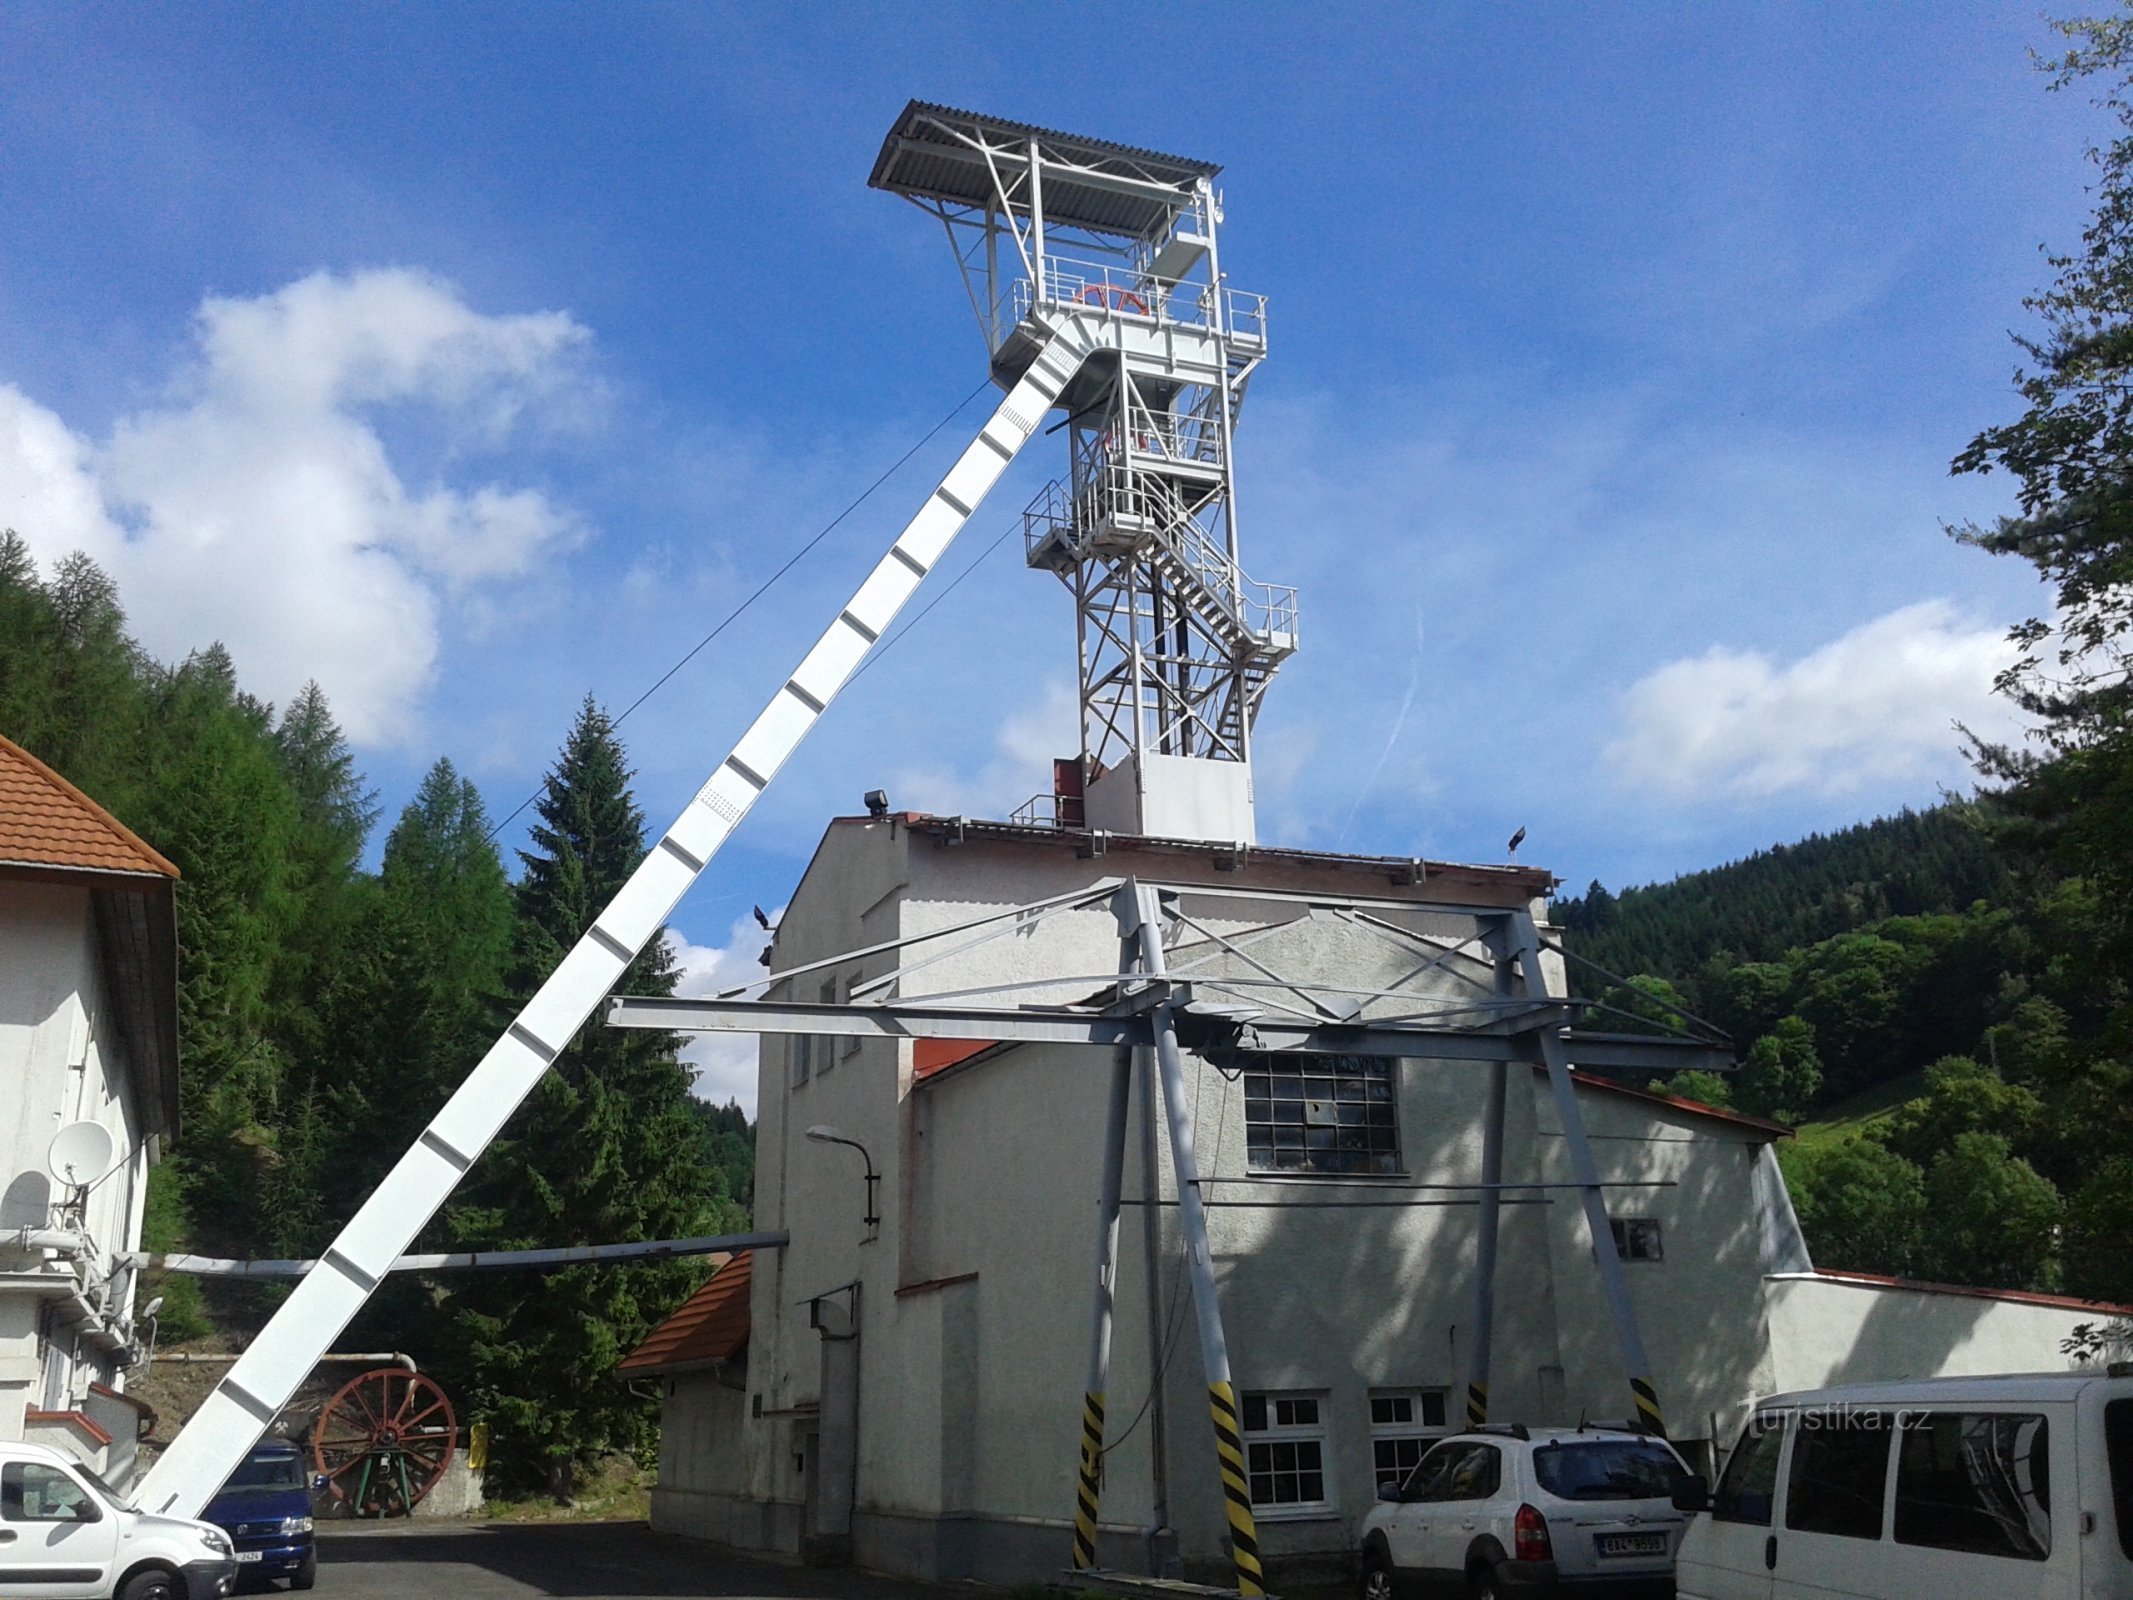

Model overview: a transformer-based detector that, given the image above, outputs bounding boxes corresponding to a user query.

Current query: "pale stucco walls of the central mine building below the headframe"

[655,821,1808,1595]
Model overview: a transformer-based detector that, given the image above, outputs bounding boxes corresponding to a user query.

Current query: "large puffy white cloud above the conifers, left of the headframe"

[0,269,589,745]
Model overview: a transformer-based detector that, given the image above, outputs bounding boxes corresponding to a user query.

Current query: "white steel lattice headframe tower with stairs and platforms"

[875,105,1297,823]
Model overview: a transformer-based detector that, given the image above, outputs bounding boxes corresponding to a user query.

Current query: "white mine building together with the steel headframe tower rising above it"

[610,102,2107,1596]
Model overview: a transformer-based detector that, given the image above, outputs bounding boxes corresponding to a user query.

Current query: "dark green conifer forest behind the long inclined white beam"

[0,533,753,1489]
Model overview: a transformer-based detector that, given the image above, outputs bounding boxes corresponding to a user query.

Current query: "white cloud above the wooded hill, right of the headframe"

[1606,599,2014,800]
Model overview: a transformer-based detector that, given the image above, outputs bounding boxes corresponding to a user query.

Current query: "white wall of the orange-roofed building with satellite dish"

[0,877,149,1467]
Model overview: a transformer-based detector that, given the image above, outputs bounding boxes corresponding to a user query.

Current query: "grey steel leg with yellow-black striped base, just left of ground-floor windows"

[1120,879,1267,1596]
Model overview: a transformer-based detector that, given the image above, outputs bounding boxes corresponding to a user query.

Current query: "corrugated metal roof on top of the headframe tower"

[866,100,1222,239]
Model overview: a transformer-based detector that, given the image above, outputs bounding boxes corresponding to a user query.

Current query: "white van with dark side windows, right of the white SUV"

[1674,1372,2133,1600]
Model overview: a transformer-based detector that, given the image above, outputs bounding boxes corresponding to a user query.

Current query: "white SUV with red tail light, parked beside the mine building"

[1361,1427,1687,1600]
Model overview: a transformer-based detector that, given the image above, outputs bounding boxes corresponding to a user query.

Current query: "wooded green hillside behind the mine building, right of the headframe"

[1557,804,2107,1297]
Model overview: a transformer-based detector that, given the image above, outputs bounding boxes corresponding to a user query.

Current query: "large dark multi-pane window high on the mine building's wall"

[1244,1054,1399,1175]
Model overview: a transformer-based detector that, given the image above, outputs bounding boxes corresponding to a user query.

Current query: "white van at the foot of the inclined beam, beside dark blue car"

[0,1440,237,1600]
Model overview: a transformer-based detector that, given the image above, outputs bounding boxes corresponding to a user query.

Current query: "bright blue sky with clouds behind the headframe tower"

[0,4,2101,1088]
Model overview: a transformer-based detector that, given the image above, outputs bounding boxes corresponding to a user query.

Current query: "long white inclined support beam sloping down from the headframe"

[134,316,1094,1517]
